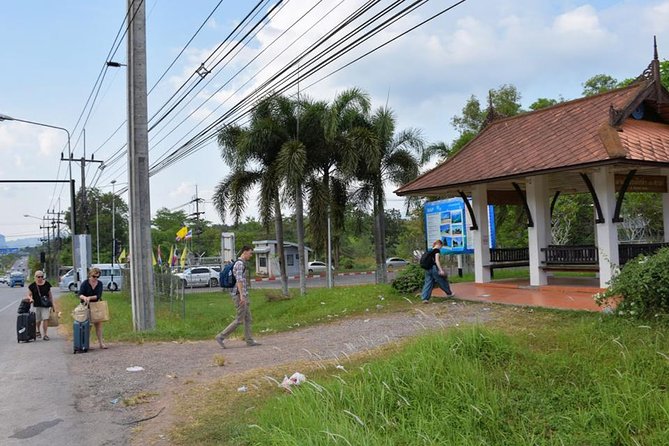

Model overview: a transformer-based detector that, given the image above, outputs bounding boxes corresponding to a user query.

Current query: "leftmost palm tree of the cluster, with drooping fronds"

[213,96,294,295]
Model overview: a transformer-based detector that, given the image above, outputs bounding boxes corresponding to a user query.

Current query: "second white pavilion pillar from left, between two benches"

[525,176,550,286]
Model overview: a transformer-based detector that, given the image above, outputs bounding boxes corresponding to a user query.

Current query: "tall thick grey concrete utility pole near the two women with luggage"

[128,0,156,331]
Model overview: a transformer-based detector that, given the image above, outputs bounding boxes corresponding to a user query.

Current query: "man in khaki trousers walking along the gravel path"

[216,245,260,348]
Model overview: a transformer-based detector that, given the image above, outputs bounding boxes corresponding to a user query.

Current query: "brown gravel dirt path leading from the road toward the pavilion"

[70,301,500,445]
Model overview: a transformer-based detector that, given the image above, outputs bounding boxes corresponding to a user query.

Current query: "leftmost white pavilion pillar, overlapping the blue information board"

[468,184,490,283]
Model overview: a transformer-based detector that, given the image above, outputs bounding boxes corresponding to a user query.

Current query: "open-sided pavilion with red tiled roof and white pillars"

[395,41,669,288]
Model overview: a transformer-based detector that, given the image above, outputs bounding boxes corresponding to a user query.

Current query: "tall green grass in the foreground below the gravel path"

[172,310,669,446]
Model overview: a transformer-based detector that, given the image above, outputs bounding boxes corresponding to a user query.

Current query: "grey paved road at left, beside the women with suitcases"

[0,270,127,446]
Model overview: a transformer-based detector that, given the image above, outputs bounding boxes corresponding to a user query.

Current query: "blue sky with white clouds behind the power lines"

[0,0,669,240]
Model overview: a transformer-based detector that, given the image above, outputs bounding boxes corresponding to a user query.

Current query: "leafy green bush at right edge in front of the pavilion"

[595,248,669,319]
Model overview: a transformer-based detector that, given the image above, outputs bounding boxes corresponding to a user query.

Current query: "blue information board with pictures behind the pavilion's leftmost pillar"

[424,198,495,254]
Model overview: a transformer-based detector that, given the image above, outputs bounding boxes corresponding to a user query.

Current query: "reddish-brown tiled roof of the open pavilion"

[396,83,669,195]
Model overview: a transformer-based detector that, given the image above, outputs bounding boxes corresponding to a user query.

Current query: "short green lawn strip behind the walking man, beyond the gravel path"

[60,285,411,342]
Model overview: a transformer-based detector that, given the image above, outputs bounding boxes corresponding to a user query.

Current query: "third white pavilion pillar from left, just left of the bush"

[593,167,619,288]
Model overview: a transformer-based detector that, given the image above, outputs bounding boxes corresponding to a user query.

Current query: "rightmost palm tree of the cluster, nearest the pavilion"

[356,107,425,283]
